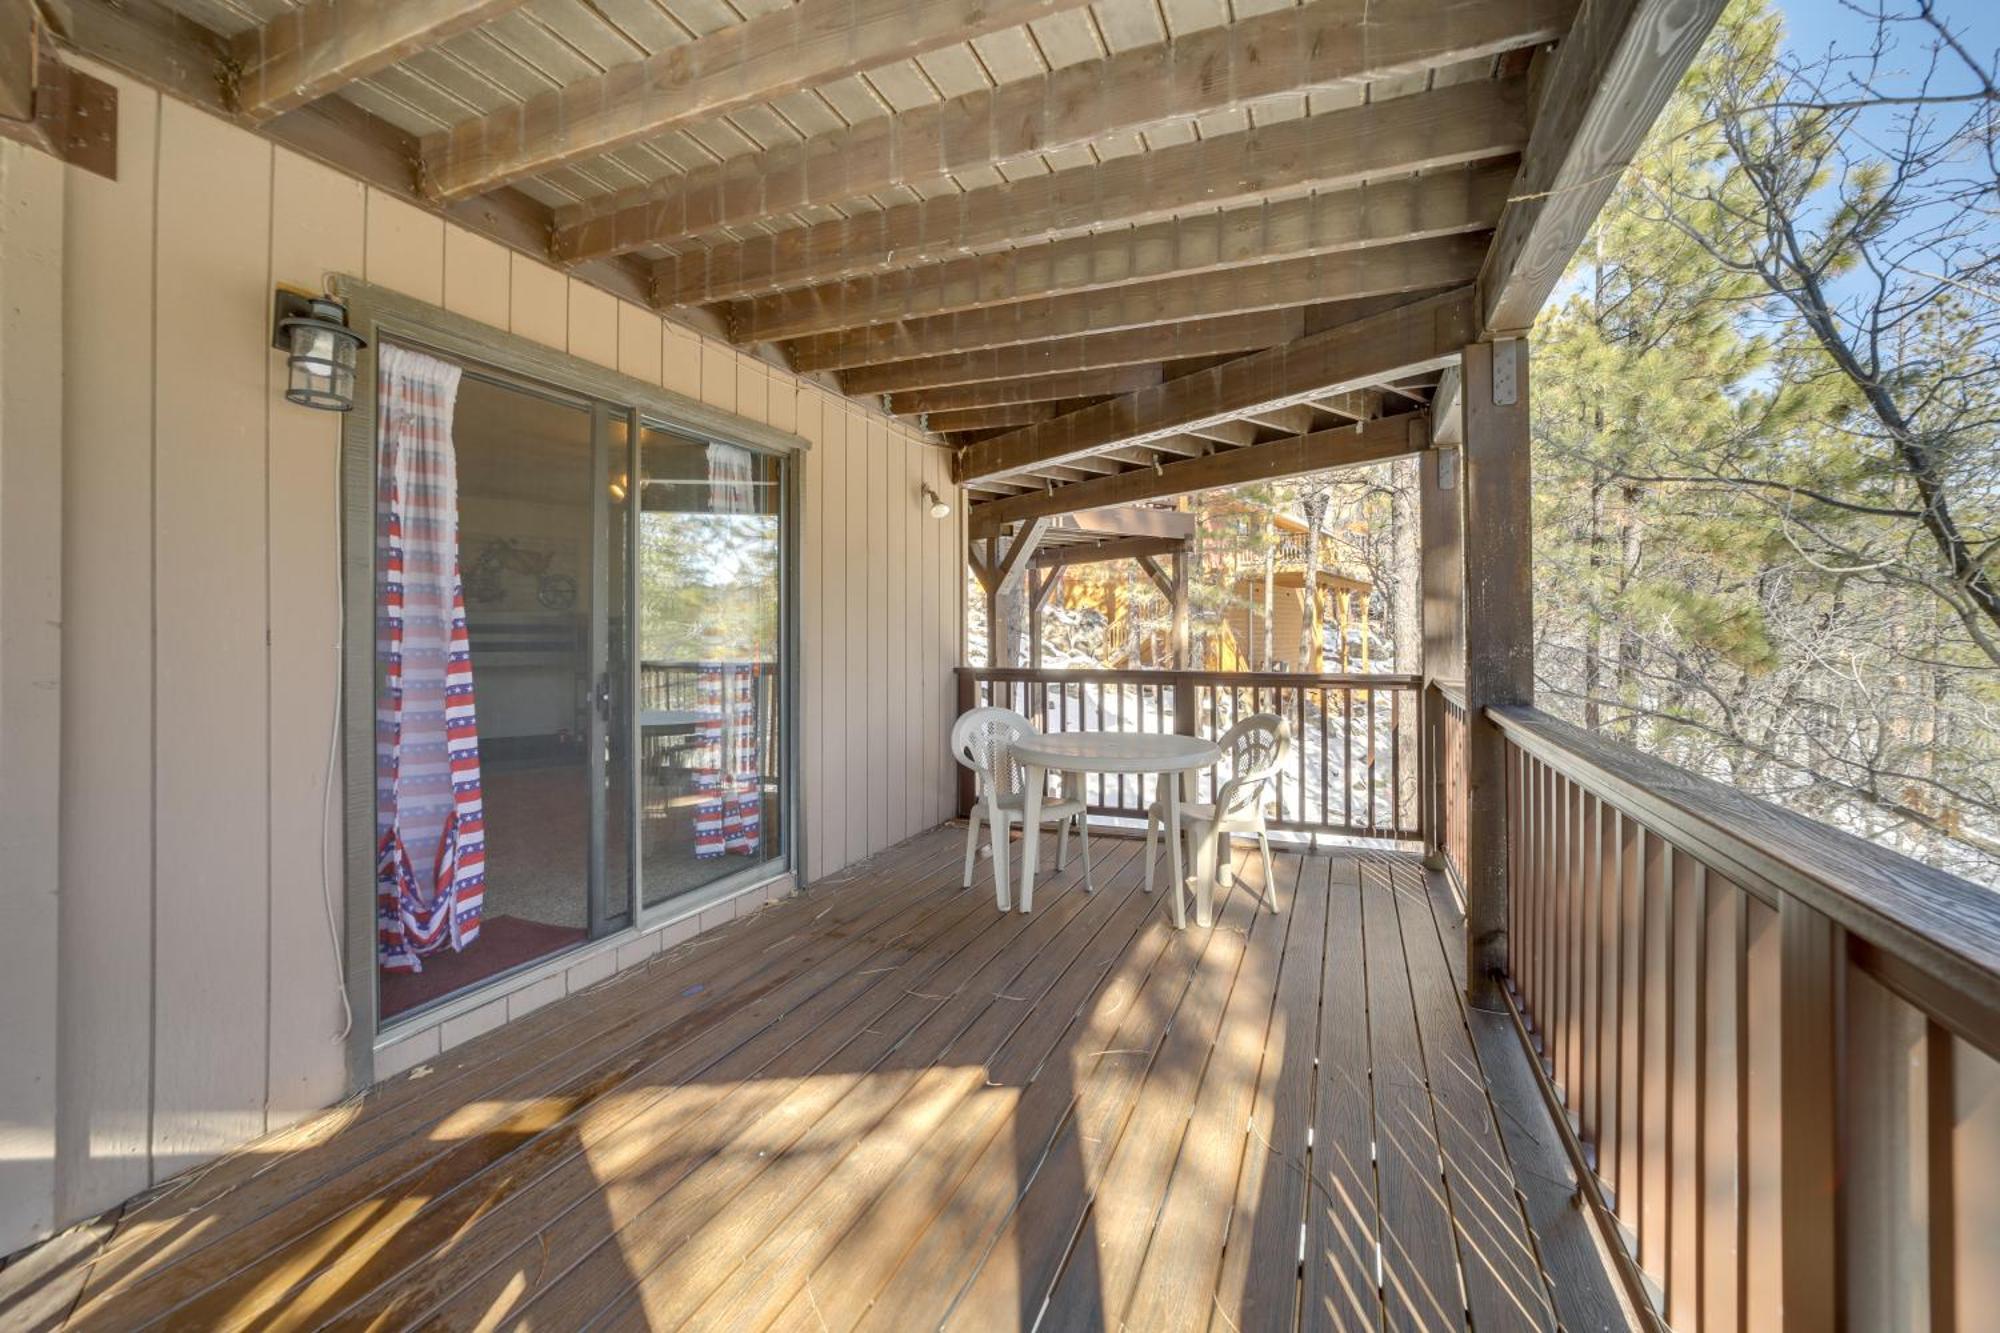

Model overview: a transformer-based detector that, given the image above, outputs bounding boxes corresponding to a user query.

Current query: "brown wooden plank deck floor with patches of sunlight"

[11,829,1618,1333]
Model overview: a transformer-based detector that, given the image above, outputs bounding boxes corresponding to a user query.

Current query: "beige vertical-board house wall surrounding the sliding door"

[0,57,964,1253]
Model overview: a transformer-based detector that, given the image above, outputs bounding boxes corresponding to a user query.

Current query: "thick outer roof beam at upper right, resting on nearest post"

[1480,0,1726,336]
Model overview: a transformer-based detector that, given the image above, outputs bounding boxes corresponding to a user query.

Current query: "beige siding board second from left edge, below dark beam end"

[56,67,160,1217]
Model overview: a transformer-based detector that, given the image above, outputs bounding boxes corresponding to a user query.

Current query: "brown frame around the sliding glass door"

[328,274,810,1093]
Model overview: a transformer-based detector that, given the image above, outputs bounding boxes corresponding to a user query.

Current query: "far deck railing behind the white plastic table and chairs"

[958,667,1422,839]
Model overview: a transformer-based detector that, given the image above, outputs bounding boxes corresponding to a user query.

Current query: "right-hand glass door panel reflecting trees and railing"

[636,428,784,907]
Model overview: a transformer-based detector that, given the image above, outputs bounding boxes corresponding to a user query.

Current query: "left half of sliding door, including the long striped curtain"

[376,364,630,1019]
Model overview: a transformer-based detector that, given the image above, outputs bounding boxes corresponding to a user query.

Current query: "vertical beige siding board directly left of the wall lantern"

[152,100,276,1177]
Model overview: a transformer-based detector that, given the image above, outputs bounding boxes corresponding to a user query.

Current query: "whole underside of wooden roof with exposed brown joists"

[60,0,1720,530]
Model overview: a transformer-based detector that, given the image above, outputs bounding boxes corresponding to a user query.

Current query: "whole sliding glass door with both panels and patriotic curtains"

[376,346,788,1021]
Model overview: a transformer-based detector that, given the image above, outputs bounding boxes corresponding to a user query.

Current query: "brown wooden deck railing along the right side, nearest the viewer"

[1488,709,2000,1333]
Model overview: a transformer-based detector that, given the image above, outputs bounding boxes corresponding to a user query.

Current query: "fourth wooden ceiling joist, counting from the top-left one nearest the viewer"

[656,78,1528,306]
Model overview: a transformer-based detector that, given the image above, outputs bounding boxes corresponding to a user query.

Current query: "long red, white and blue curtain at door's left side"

[376,346,486,971]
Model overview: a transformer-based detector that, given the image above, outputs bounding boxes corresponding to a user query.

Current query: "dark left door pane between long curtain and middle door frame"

[378,372,592,1019]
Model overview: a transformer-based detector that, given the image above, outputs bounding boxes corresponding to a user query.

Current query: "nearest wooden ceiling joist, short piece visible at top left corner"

[230,0,524,122]
